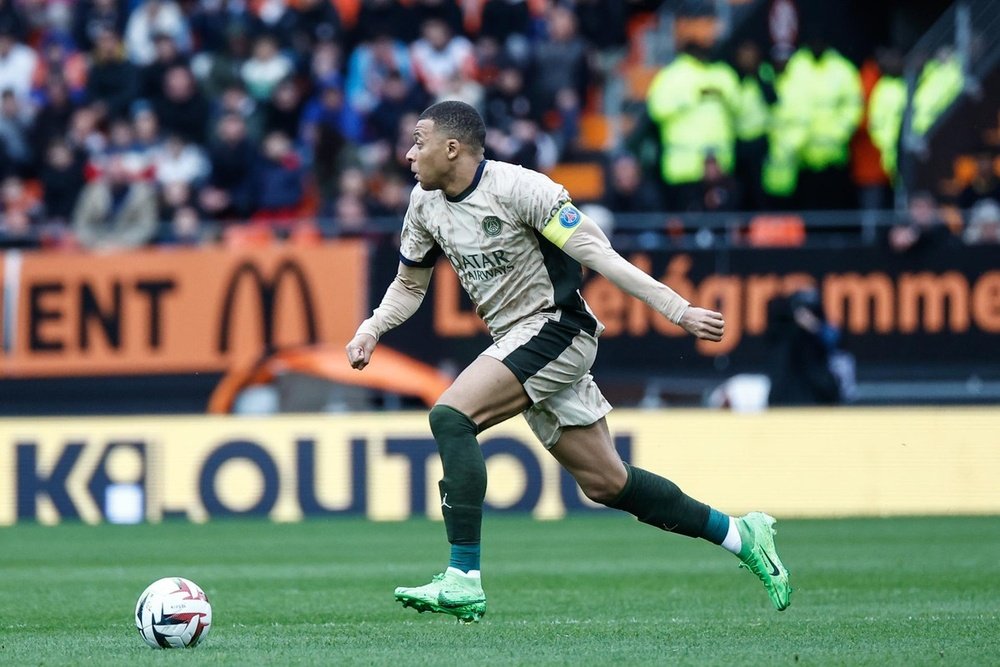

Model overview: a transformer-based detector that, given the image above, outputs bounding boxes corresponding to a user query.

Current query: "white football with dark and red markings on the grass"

[135,577,212,648]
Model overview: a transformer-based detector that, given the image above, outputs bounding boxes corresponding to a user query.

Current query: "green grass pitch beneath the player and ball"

[0,516,1000,666]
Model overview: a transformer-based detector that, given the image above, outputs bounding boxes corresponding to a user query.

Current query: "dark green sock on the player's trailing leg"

[608,464,711,537]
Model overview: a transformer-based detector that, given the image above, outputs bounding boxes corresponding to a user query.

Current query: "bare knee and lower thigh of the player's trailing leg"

[549,418,628,501]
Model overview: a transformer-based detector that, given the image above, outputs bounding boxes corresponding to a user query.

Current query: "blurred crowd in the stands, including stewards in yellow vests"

[0,0,1000,249]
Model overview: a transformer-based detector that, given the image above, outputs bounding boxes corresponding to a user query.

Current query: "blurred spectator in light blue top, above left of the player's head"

[344,32,414,114]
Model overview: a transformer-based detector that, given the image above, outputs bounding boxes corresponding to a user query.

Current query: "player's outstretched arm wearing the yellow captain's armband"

[542,203,725,341]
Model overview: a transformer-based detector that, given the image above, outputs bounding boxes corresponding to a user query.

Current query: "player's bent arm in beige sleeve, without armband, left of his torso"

[347,262,434,370]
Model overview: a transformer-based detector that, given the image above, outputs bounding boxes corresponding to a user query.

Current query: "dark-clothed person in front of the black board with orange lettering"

[765,289,844,406]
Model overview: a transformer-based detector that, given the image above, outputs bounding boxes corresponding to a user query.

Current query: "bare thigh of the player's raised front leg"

[437,356,531,429]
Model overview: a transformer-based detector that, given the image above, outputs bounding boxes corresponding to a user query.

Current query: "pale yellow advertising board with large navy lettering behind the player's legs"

[0,408,1000,525]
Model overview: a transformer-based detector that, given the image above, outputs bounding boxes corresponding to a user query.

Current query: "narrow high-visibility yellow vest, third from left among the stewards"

[761,70,812,197]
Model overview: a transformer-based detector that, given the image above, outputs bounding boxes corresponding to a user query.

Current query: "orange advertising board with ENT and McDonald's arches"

[0,241,368,377]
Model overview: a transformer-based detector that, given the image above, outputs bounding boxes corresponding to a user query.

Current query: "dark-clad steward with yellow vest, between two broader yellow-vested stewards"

[734,41,776,211]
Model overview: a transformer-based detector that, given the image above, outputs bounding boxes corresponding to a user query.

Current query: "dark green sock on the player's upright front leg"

[430,405,486,544]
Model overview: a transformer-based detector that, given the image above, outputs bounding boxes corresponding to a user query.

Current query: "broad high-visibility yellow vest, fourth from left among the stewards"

[782,48,863,171]
